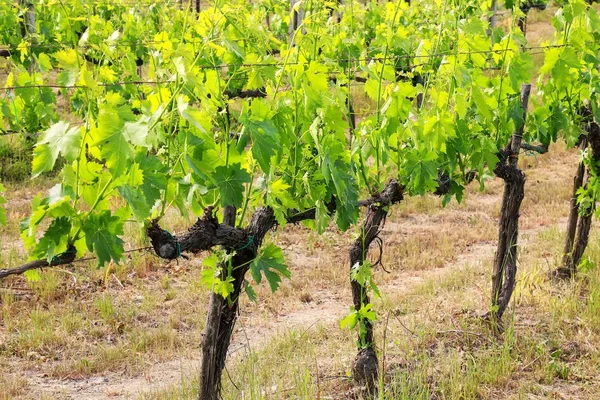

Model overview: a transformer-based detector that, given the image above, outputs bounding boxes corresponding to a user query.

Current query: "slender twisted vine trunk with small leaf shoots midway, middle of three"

[350,180,403,396]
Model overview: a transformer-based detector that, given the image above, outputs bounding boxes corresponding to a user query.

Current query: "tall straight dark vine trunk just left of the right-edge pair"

[491,84,531,320]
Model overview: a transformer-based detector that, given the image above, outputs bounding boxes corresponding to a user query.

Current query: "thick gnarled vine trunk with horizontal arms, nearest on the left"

[146,197,366,400]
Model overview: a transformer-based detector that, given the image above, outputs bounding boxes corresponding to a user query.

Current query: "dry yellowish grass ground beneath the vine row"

[0,140,600,399]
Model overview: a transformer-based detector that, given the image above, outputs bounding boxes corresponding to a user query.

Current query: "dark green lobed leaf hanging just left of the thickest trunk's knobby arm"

[82,210,124,268]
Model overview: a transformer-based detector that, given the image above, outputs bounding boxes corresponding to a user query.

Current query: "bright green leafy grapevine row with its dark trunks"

[0,0,600,399]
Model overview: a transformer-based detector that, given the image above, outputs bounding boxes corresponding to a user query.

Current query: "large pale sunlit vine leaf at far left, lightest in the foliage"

[32,121,81,177]
